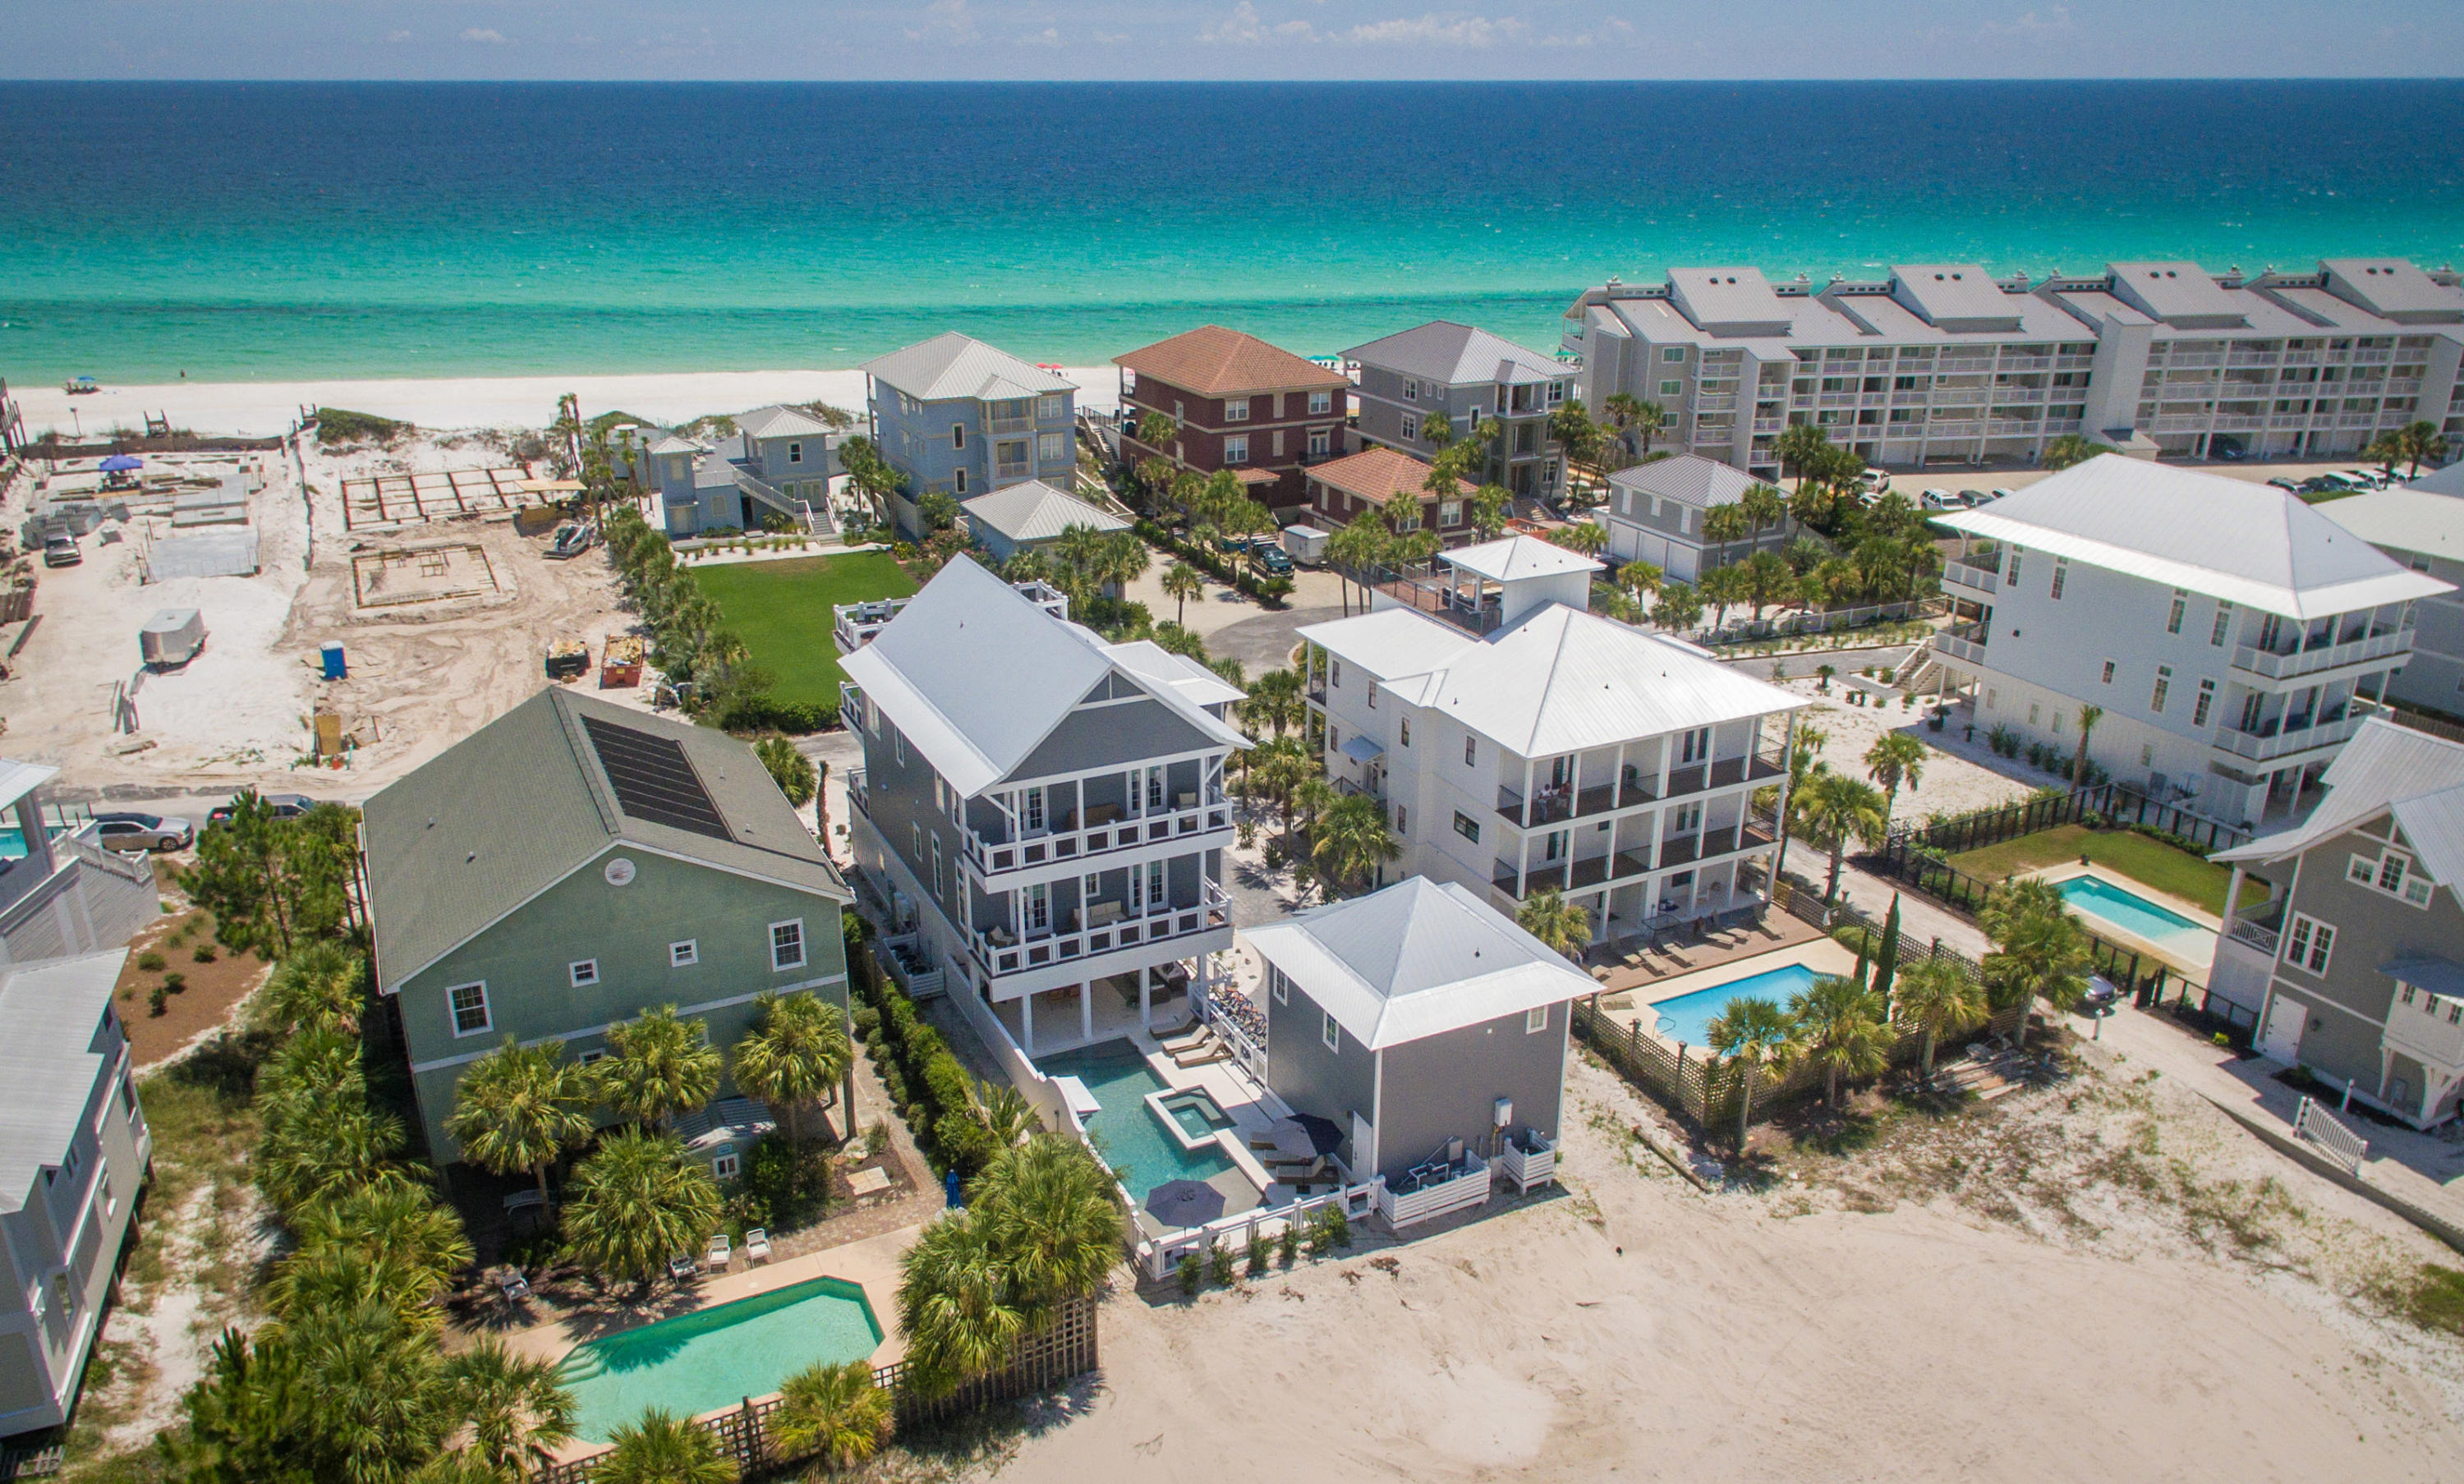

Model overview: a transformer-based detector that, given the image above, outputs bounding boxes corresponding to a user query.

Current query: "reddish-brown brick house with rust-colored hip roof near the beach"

[1111,325,1353,520]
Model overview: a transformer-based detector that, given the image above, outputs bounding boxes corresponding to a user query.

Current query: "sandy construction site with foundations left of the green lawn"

[0,421,648,802]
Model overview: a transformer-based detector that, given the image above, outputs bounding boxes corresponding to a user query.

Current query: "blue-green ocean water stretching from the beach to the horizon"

[0,81,2464,382]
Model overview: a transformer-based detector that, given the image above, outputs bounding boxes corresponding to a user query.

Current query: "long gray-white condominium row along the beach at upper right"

[1562,259,2464,478]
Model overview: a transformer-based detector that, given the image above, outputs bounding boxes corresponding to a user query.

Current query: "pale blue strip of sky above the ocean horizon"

[19,0,2464,80]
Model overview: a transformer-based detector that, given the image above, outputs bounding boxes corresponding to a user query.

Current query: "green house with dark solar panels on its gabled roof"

[360,687,850,1164]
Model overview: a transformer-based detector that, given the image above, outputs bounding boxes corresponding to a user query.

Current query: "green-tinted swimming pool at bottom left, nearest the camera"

[559,1277,882,1442]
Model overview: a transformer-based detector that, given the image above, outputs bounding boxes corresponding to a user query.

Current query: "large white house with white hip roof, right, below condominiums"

[1917,453,2452,829]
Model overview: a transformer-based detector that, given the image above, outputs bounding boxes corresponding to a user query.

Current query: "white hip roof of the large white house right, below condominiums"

[1934,453,2449,618]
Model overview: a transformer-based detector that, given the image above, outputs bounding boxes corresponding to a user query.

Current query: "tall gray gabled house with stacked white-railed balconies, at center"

[840,559,1249,1055]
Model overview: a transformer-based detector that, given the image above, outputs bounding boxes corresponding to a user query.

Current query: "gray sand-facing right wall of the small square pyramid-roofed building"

[1380,1004,1572,1181]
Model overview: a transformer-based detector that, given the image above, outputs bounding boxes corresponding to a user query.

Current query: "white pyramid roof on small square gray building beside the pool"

[1247,875,1597,1050]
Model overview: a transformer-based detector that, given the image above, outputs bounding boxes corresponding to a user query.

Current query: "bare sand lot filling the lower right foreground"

[998,1045,2464,1484]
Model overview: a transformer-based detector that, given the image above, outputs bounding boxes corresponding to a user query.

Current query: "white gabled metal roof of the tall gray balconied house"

[838,557,1249,794]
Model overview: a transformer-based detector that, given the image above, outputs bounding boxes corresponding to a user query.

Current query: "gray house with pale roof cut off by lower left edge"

[0,949,153,1442]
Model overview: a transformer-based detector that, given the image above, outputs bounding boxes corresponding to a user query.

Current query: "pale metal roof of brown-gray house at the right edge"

[2213,717,2464,888]
